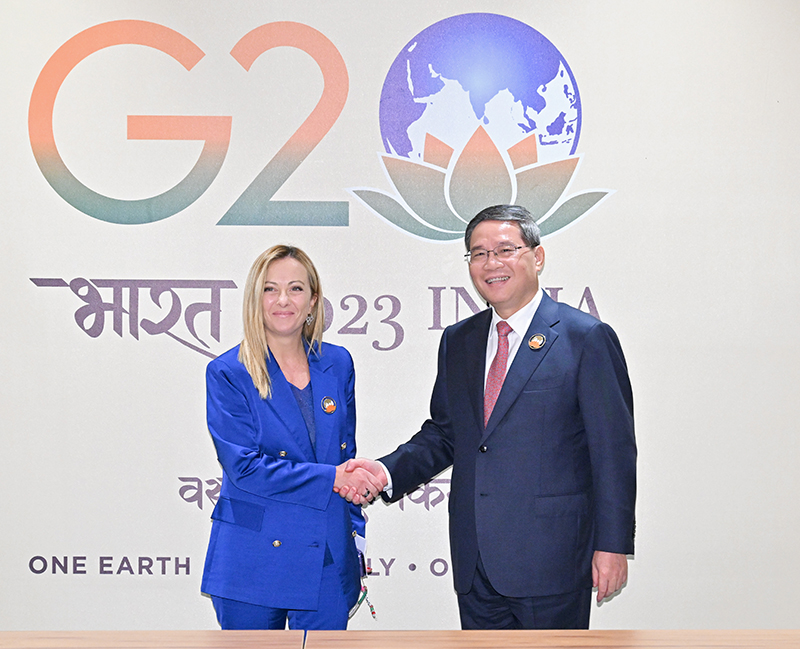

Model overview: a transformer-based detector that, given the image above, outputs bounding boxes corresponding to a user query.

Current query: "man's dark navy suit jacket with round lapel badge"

[381,294,636,597]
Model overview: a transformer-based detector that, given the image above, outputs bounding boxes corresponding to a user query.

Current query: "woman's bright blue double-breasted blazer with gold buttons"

[202,343,364,610]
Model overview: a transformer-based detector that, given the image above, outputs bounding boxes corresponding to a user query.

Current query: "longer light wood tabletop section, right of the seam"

[305,630,800,649]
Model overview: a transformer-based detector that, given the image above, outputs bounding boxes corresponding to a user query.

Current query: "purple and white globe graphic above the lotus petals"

[380,13,581,162]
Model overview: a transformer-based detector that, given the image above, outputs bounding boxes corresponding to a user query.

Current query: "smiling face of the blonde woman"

[261,257,317,343]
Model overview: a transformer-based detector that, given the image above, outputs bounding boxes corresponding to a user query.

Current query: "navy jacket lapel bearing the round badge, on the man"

[481,293,559,441]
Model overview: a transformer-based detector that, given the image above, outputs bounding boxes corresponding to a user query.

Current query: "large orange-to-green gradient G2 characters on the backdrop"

[28,20,349,225]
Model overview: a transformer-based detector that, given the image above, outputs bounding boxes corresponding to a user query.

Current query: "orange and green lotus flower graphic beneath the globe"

[350,125,610,241]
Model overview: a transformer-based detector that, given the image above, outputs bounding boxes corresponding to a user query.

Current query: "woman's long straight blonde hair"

[239,245,325,399]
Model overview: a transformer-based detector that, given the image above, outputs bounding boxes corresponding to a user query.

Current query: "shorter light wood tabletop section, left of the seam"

[0,631,303,649]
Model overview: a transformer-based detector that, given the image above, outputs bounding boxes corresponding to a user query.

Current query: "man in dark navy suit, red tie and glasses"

[343,205,636,629]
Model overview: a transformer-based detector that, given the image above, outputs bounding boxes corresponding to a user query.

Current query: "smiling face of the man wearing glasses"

[469,221,544,319]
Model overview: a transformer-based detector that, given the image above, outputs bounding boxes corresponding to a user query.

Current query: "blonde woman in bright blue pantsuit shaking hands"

[202,245,381,629]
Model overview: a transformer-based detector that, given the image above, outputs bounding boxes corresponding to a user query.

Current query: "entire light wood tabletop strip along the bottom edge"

[0,630,800,649]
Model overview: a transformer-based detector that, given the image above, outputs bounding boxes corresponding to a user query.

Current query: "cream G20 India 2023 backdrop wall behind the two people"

[0,0,800,630]
